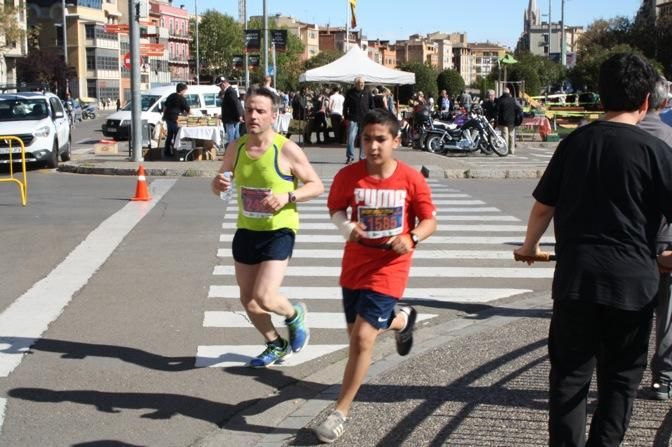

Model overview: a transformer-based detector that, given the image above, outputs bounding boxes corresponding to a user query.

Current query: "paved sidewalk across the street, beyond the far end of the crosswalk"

[58,142,557,178]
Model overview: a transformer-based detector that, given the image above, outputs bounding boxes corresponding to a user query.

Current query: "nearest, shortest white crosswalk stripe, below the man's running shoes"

[194,344,348,368]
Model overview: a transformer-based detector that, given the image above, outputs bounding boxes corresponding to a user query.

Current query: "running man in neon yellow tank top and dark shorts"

[212,87,324,368]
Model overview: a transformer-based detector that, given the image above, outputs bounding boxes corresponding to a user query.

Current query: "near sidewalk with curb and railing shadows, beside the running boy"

[201,294,672,447]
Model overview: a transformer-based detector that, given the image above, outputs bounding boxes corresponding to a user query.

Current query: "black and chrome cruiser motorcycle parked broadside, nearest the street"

[425,105,509,157]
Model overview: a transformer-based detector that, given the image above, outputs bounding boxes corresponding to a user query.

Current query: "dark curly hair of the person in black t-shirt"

[599,53,658,112]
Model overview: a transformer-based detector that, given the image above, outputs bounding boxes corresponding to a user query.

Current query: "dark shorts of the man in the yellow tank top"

[231,228,296,265]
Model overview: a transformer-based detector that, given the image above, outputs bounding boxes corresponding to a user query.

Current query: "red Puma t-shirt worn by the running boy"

[327,160,436,298]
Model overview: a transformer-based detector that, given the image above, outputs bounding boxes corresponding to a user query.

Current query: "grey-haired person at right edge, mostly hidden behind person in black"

[639,76,672,400]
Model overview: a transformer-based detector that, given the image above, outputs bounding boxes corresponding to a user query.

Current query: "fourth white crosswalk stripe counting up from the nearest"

[213,265,555,278]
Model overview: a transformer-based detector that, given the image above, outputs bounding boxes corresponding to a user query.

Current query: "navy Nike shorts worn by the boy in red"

[343,288,399,329]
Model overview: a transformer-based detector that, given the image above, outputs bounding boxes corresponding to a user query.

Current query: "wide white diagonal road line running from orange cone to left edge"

[0,180,176,377]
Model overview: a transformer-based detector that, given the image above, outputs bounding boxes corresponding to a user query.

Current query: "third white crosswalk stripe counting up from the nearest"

[208,286,532,303]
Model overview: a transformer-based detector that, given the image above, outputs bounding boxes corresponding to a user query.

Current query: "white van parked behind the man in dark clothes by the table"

[103,85,222,140]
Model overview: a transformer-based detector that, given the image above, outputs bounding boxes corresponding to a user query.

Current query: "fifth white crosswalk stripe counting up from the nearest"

[217,247,524,261]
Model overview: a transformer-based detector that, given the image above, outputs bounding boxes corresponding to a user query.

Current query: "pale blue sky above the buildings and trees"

[192,0,641,46]
